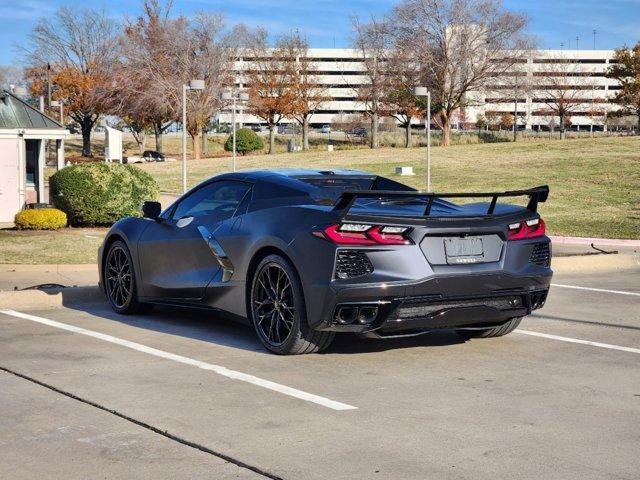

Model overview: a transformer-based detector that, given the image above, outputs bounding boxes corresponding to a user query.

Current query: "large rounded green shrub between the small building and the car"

[49,162,159,226]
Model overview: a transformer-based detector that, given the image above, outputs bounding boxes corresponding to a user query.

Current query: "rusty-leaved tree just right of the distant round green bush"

[246,29,296,154]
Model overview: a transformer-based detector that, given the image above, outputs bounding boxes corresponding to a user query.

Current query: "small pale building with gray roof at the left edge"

[0,90,69,222]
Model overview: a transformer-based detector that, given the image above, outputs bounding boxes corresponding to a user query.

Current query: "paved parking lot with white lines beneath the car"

[0,268,640,480]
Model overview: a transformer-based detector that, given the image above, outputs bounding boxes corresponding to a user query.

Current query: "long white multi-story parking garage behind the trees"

[220,48,620,129]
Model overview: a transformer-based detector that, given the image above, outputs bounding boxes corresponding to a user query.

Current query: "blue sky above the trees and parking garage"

[0,0,640,66]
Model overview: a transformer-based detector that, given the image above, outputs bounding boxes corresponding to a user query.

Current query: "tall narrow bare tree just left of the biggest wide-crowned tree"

[352,17,390,148]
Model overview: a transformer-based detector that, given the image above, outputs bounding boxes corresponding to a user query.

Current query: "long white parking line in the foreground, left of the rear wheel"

[0,310,358,410]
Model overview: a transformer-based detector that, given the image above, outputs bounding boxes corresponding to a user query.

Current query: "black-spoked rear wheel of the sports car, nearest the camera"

[247,255,335,355]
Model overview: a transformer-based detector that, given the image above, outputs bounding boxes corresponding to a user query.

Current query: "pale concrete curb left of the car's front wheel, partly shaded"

[0,286,105,310]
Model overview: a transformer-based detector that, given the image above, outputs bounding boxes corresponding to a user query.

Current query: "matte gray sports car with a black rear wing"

[99,170,552,354]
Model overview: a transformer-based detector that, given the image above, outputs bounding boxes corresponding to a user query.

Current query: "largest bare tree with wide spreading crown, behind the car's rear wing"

[389,0,530,146]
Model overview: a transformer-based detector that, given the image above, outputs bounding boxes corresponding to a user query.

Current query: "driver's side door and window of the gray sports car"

[138,180,251,302]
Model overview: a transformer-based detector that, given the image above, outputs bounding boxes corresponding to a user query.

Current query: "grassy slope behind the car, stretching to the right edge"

[140,137,640,238]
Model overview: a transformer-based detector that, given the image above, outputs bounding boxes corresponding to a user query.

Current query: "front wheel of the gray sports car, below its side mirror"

[102,240,153,315]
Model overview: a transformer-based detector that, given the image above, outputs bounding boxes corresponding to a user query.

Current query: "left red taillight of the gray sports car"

[313,223,412,245]
